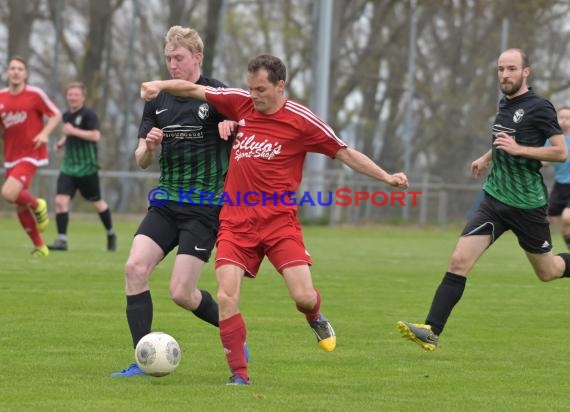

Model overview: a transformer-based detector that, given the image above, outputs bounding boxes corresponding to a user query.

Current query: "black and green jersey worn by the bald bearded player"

[483,89,562,209]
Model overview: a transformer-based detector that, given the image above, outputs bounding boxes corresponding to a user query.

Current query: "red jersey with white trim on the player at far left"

[0,85,59,168]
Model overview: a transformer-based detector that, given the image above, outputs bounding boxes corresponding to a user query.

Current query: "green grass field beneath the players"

[0,216,570,412]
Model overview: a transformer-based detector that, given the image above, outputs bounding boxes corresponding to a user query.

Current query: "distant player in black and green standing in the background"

[48,83,117,252]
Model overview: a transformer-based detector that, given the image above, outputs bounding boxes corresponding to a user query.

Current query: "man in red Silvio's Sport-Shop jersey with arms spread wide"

[141,54,408,385]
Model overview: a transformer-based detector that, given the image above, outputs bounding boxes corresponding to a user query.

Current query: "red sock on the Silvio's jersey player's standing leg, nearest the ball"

[220,313,249,380]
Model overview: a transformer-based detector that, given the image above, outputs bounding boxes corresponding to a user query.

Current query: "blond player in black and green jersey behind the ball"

[112,26,231,377]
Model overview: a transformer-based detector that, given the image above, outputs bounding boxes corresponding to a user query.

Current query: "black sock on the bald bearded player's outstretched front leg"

[426,272,467,335]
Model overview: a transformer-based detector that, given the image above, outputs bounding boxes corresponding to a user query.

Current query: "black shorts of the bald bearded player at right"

[461,193,552,254]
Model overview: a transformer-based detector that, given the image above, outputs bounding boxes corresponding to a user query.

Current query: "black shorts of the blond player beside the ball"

[136,202,221,262]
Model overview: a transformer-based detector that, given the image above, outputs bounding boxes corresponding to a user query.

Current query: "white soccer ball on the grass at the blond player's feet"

[135,332,182,376]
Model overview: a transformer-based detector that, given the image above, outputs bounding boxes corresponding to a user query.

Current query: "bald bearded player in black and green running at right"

[397,49,570,351]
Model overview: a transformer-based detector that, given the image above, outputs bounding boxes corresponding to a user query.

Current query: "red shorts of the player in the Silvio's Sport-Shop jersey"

[216,206,313,278]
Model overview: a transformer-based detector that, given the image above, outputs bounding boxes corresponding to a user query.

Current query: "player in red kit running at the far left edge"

[0,57,61,257]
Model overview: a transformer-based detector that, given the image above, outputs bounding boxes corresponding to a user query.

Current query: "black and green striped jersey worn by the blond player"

[139,76,231,205]
